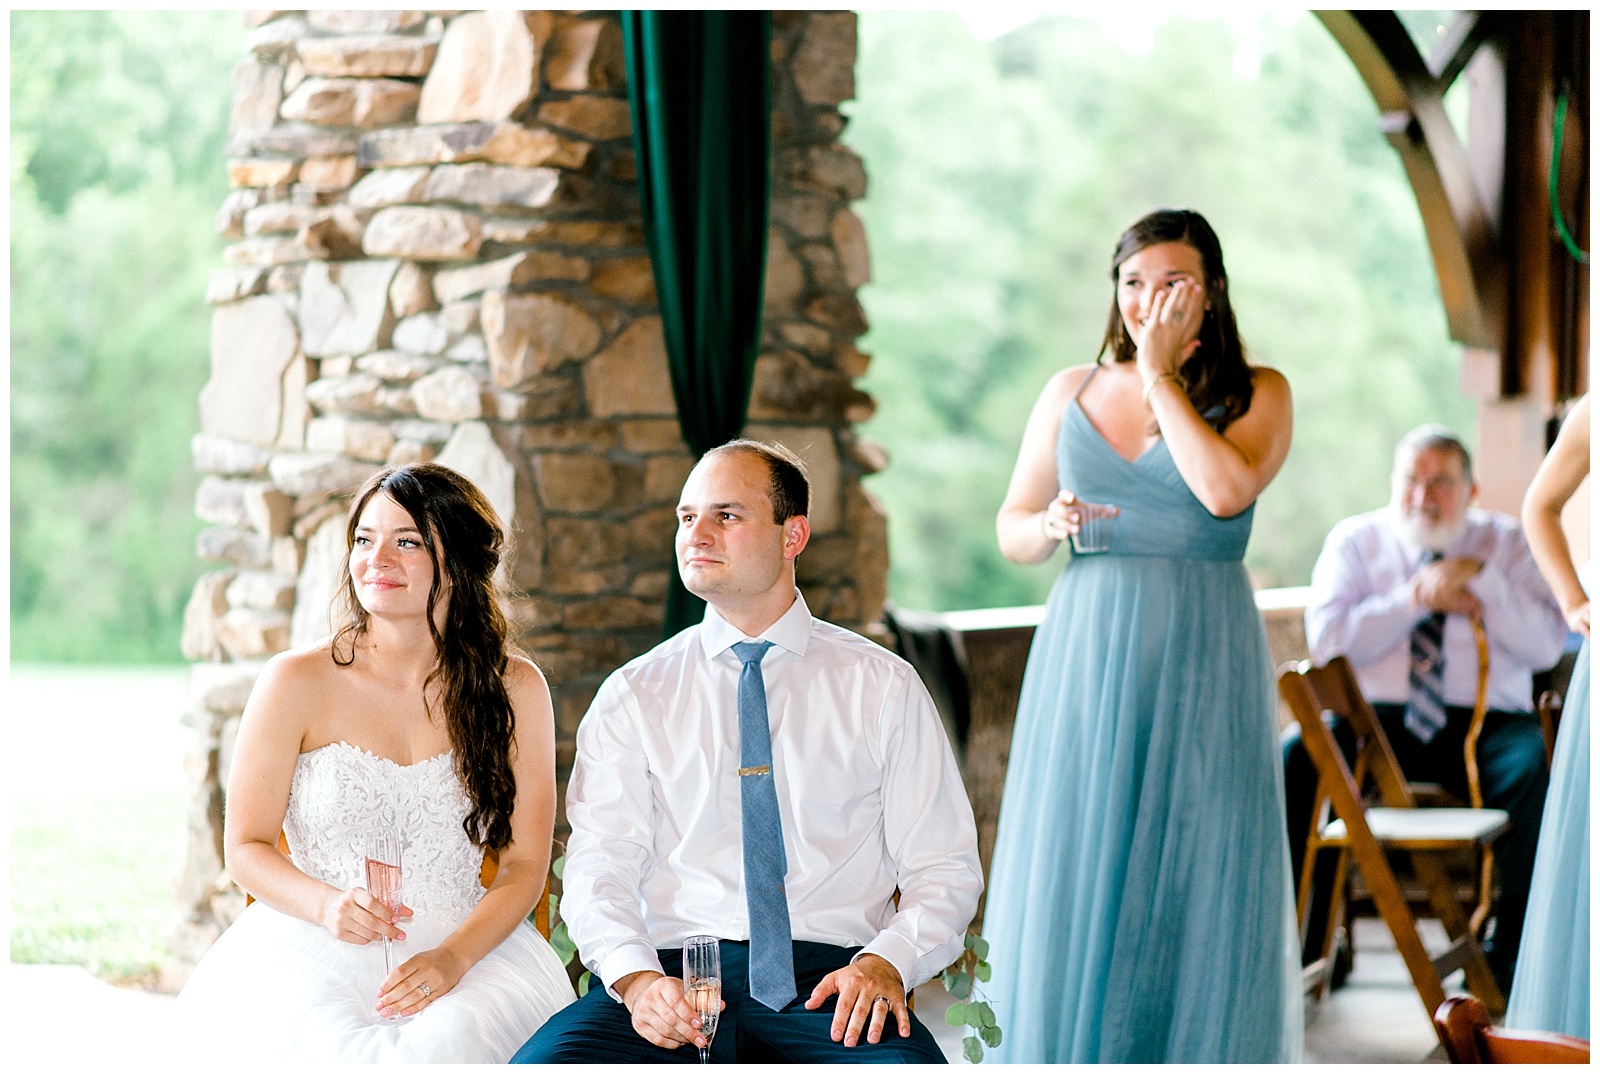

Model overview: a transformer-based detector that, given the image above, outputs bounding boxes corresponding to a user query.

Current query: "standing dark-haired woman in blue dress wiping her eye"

[984,210,1302,1063]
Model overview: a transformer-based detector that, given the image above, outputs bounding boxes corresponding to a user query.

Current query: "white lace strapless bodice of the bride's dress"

[283,743,483,919]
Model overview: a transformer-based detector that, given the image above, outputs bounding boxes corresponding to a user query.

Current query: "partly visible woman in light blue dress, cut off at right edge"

[1506,395,1589,1039]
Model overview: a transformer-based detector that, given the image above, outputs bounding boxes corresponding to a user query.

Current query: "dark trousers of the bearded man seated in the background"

[1282,703,1550,989]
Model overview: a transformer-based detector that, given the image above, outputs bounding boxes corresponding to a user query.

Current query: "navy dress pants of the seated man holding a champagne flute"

[510,940,944,1063]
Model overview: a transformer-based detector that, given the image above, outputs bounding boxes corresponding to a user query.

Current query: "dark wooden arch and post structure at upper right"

[1317,11,1589,512]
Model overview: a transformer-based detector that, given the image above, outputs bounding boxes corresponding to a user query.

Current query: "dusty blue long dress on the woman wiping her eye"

[982,373,1304,1063]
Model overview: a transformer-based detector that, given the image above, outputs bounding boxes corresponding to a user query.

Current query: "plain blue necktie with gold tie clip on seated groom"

[733,642,795,1010]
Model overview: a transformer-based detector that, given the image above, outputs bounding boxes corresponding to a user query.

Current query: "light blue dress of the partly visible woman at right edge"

[1506,642,1589,1039]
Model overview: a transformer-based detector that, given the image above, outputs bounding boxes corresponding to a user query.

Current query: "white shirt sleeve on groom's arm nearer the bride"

[562,674,661,1000]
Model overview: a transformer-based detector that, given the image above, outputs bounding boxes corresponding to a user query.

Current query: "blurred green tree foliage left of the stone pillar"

[11,11,243,663]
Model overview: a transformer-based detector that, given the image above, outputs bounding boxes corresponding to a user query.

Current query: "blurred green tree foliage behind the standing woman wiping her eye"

[845,11,1472,608]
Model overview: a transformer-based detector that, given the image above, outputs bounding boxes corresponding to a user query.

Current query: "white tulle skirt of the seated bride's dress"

[173,903,573,1066]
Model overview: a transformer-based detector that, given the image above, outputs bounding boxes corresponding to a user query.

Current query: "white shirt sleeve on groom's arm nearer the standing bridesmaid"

[858,667,984,991]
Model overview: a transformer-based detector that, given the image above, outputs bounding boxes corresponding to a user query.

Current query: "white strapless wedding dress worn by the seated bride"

[173,743,573,1064]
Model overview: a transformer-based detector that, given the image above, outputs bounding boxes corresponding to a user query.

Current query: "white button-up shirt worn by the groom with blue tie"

[562,592,982,996]
